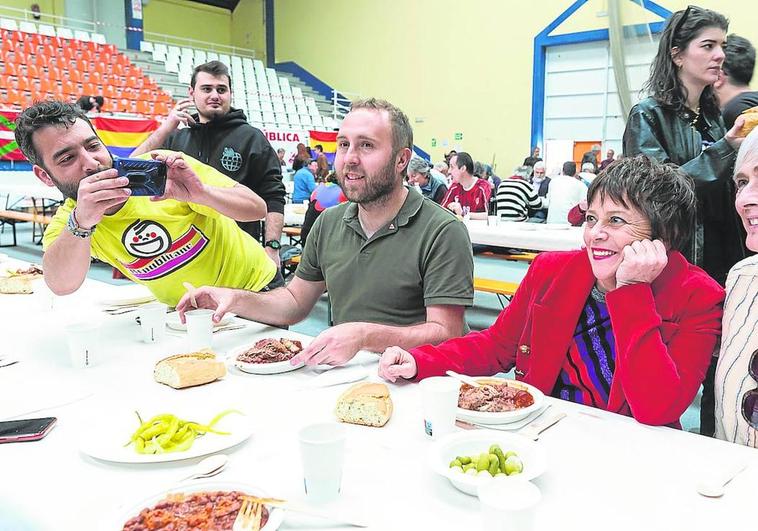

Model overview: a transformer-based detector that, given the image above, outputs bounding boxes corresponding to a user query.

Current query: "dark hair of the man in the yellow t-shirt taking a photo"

[14,100,95,167]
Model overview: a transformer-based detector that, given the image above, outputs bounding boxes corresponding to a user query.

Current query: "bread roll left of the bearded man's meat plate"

[153,350,226,389]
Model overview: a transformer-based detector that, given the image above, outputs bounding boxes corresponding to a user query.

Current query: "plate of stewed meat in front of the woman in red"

[457,378,545,424]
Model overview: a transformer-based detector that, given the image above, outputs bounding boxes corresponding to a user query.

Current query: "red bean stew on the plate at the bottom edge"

[124,491,269,531]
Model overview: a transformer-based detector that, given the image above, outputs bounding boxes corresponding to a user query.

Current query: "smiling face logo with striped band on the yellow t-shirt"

[121,220,209,281]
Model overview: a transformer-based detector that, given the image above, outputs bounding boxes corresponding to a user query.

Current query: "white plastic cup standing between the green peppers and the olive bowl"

[298,422,346,503]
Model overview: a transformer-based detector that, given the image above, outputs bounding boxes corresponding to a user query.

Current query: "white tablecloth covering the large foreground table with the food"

[0,281,758,531]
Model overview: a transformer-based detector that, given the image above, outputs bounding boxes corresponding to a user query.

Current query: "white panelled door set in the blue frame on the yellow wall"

[543,35,658,171]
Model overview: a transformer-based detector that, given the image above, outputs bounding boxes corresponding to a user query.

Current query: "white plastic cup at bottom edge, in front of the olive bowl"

[477,477,542,531]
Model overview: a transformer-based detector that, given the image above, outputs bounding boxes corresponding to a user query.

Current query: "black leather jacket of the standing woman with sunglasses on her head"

[624,98,745,285]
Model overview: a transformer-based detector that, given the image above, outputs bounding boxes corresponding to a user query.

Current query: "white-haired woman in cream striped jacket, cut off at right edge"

[715,129,758,448]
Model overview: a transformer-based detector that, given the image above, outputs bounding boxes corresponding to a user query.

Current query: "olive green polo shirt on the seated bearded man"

[295,192,474,325]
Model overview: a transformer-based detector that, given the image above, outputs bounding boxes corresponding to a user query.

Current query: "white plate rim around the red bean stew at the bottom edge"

[108,481,284,531]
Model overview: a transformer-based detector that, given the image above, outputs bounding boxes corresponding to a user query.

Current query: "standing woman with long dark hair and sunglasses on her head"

[624,6,745,286]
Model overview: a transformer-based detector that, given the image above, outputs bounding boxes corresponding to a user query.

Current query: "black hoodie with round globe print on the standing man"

[164,109,286,237]
